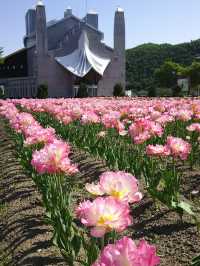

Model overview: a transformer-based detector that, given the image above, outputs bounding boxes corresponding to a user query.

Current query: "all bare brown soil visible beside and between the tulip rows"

[0,119,200,266]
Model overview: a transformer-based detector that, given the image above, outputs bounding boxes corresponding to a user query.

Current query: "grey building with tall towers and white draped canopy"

[0,1,125,98]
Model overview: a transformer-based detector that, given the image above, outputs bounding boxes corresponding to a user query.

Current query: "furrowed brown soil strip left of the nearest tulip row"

[0,120,65,266]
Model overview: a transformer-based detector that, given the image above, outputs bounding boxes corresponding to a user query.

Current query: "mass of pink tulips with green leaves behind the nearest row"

[14,99,200,222]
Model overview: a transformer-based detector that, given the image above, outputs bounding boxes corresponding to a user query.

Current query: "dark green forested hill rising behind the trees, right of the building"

[126,39,200,90]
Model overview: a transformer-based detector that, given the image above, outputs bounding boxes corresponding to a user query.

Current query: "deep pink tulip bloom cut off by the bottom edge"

[92,237,160,266]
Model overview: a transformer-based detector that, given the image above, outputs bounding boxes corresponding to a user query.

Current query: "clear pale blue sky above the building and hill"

[0,0,200,54]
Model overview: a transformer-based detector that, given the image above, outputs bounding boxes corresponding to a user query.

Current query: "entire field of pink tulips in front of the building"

[0,97,200,266]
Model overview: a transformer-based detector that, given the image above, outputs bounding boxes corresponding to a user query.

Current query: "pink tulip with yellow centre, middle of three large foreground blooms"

[76,197,132,237]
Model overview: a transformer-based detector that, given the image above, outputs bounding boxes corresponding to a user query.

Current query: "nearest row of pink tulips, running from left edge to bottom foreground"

[0,101,160,266]
